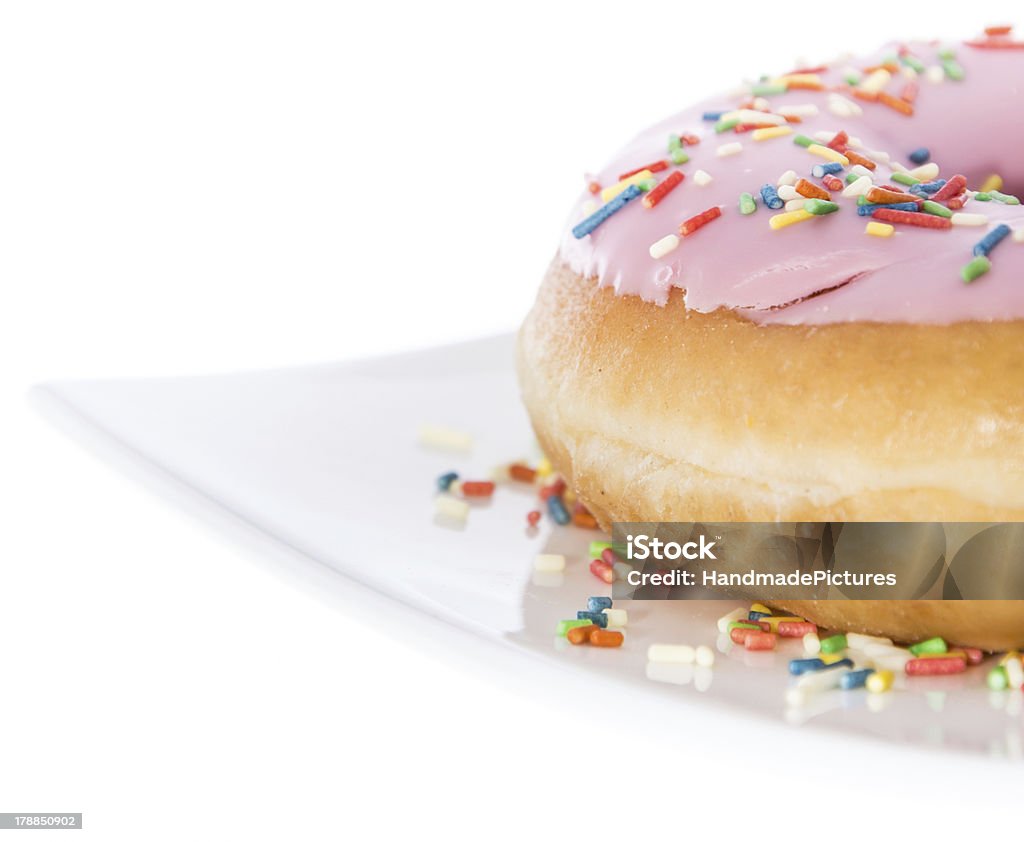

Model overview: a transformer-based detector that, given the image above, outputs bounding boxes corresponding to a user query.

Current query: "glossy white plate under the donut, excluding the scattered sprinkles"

[37,336,1024,760]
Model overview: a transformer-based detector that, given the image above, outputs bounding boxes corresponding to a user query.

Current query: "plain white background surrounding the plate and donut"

[0,0,1019,839]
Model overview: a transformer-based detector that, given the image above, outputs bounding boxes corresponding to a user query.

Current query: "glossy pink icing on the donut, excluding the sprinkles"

[560,38,1024,324]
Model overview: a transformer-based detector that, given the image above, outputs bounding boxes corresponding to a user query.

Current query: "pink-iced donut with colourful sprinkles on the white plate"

[517,28,1024,649]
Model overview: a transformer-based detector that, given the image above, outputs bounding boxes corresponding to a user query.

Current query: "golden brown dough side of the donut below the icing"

[517,260,1024,648]
